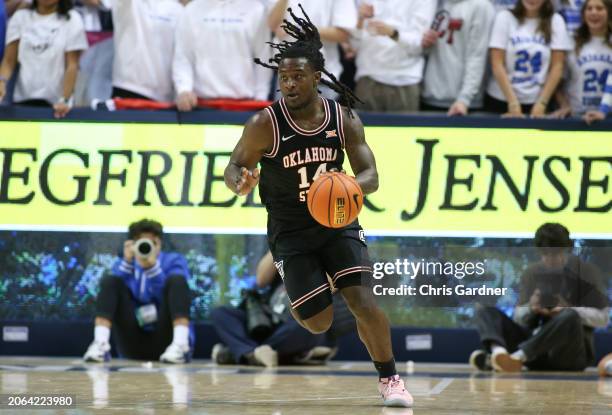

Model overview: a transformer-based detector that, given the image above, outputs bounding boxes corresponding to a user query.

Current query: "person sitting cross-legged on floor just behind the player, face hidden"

[211,252,332,367]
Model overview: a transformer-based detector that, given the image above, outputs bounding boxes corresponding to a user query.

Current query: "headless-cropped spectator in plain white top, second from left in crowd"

[112,0,183,102]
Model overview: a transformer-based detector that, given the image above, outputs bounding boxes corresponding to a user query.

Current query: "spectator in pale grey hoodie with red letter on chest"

[421,0,494,115]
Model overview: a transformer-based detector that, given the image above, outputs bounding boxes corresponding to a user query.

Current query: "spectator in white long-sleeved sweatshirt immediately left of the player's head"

[172,0,272,111]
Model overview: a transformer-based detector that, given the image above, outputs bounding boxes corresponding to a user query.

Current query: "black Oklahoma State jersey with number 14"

[259,97,344,231]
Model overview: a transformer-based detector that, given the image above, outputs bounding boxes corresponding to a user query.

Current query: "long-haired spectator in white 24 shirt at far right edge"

[555,0,612,117]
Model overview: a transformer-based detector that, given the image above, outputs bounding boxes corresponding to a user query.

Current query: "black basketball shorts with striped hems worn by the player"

[270,226,372,319]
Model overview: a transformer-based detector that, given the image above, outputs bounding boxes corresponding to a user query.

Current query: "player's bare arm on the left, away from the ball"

[224,110,274,196]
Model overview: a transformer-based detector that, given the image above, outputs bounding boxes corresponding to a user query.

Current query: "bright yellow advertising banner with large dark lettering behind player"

[0,122,612,238]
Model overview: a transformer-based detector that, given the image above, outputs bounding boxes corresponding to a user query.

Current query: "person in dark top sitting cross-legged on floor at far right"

[470,223,609,372]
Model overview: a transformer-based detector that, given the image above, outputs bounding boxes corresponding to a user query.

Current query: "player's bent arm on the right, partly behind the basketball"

[342,108,378,194]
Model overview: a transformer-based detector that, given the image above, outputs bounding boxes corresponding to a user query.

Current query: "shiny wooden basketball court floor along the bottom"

[0,357,612,415]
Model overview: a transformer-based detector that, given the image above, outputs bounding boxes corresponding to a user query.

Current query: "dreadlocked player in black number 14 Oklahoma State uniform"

[225,7,413,407]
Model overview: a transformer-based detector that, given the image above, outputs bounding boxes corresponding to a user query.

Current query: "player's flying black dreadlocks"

[255,4,362,117]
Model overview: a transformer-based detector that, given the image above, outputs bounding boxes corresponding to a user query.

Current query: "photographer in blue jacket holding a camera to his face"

[83,219,191,363]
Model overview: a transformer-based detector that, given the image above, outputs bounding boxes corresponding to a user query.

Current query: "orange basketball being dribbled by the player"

[306,172,363,228]
